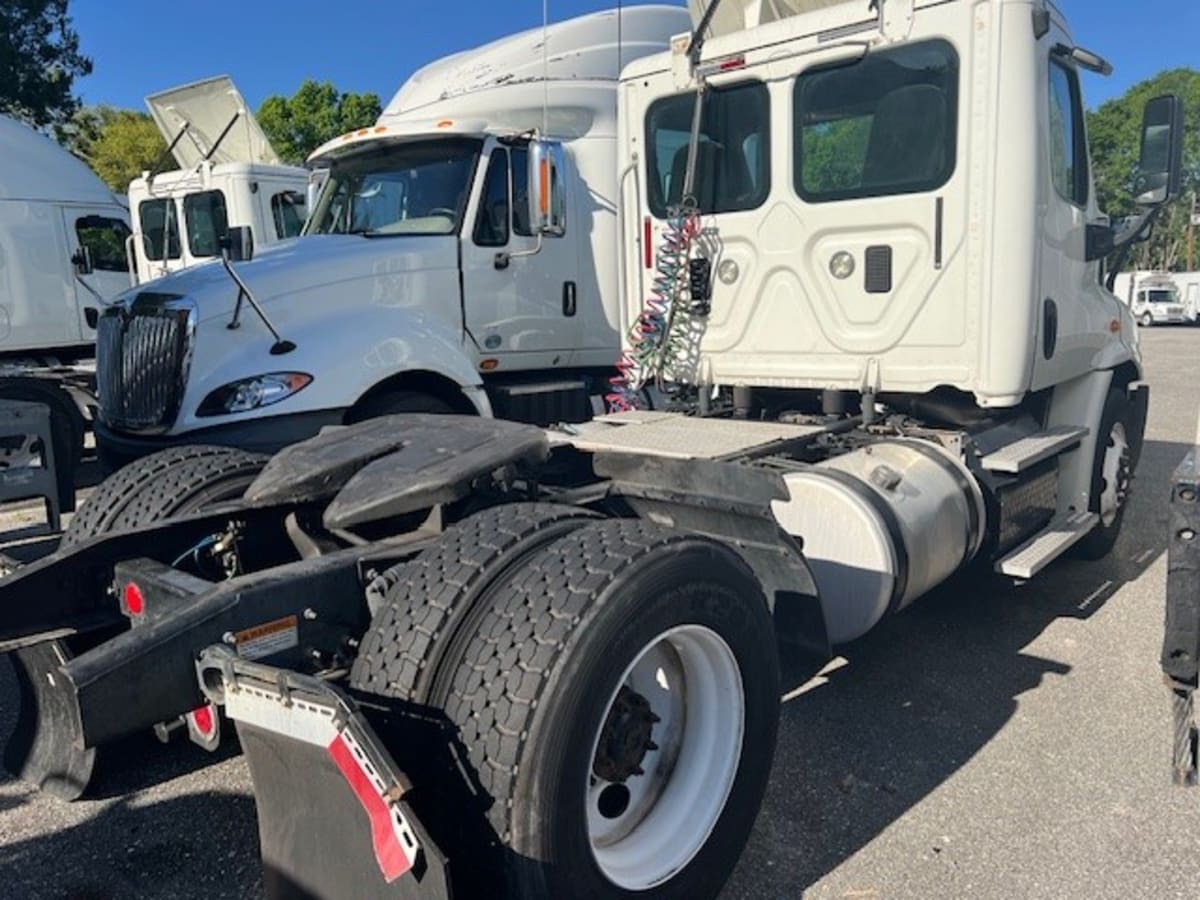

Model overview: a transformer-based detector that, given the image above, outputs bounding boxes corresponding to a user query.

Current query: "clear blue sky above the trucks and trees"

[70,0,1200,109]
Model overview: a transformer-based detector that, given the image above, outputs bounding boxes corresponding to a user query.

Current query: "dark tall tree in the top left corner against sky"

[0,0,91,128]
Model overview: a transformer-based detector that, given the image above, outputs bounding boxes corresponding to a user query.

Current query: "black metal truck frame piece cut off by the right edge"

[1163,446,1200,786]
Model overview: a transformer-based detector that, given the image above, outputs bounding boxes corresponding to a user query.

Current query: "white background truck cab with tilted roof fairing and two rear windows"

[128,76,308,283]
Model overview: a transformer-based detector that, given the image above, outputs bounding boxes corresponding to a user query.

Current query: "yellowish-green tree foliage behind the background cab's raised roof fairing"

[56,106,167,193]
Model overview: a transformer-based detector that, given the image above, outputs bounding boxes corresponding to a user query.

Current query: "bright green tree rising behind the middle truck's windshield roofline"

[258,80,383,162]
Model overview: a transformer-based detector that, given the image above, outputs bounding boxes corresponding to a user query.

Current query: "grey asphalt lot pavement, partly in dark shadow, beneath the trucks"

[0,328,1200,900]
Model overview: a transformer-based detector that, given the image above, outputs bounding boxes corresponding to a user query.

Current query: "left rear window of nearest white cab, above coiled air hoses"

[646,82,770,218]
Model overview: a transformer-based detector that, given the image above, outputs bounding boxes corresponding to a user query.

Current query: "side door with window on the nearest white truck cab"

[1032,48,1120,390]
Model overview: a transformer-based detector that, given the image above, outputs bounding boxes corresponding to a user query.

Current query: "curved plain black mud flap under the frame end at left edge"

[4,641,96,800]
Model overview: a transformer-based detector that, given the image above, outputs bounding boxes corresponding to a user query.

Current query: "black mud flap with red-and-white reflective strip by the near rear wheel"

[197,647,450,900]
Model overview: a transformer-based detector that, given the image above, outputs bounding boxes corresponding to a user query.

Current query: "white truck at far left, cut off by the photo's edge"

[0,116,130,509]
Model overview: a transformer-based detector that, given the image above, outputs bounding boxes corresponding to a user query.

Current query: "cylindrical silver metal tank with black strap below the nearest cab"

[773,438,986,643]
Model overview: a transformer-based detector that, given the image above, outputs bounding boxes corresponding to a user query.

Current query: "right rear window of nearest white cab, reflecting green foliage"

[792,41,959,203]
